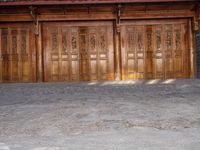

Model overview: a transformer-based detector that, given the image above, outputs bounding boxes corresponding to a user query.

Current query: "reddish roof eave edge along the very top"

[0,0,200,6]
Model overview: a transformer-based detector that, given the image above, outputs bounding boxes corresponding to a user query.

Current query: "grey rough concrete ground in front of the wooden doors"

[0,80,200,150]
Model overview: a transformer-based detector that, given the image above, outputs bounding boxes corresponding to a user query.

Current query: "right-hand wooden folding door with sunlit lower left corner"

[121,19,190,80]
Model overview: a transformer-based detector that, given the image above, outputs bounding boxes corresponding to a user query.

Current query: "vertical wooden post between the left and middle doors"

[35,22,43,82]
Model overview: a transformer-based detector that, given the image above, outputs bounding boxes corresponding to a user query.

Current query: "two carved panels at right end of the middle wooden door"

[88,25,114,80]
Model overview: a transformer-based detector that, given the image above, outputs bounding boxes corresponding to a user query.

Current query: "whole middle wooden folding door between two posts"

[43,22,114,81]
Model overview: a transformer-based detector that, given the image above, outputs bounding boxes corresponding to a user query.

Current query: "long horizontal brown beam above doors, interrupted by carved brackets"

[0,11,195,22]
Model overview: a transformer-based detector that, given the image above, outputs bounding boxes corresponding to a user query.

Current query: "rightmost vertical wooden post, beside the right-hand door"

[189,20,197,79]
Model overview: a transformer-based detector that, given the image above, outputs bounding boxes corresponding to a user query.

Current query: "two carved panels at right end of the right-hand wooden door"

[163,22,189,79]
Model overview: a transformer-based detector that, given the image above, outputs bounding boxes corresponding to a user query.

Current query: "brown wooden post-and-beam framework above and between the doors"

[0,2,199,82]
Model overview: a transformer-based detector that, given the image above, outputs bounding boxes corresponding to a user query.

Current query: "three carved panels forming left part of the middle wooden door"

[43,26,79,81]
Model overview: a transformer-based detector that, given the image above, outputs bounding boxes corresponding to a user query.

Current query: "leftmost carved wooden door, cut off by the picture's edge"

[0,24,36,82]
